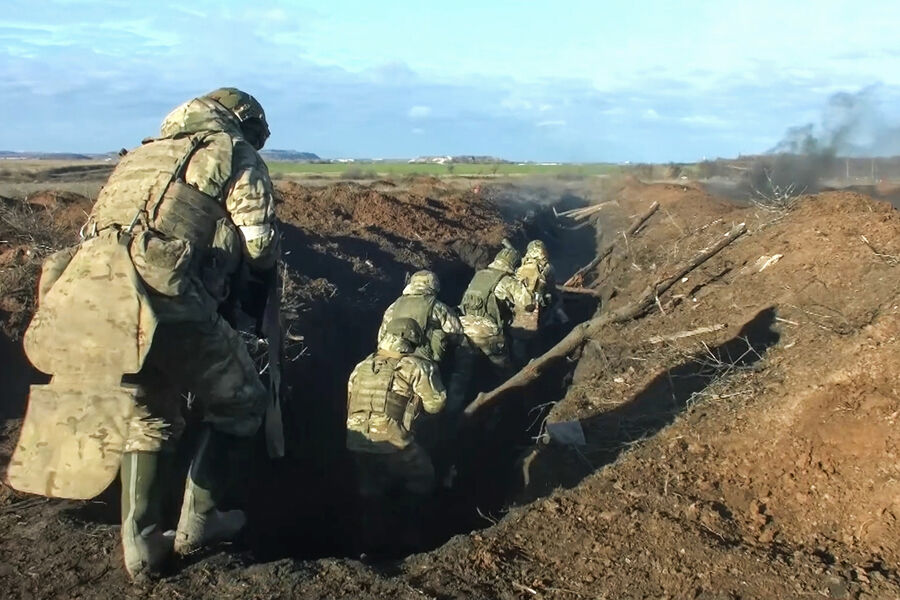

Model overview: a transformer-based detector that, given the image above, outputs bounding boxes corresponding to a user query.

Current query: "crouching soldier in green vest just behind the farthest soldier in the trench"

[448,248,534,411]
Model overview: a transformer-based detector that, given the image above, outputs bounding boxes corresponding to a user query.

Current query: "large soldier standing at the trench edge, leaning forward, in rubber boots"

[10,88,278,578]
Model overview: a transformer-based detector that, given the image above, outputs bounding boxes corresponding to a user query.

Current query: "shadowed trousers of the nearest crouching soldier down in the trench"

[351,442,435,498]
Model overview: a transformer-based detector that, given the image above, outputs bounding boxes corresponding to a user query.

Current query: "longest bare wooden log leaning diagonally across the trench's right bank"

[464,223,747,417]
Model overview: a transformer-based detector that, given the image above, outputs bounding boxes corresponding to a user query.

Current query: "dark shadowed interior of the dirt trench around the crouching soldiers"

[236,178,597,561]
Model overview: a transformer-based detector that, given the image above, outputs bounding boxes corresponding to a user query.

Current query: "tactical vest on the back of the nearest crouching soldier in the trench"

[347,351,410,426]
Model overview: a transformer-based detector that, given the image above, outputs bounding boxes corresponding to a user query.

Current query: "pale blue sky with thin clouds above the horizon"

[0,0,900,161]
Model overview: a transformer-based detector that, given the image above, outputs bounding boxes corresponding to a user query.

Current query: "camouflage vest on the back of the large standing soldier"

[88,133,230,247]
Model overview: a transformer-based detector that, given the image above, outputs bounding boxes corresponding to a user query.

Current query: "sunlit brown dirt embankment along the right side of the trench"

[438,182,900,598]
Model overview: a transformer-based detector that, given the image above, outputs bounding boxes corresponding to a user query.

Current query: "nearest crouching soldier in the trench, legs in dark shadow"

[347,318,446,549]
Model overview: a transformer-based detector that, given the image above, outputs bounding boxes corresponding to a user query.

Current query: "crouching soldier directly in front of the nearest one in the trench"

[378,271,463,364]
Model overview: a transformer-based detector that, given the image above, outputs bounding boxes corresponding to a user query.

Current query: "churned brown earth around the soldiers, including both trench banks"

[0,171,900,599]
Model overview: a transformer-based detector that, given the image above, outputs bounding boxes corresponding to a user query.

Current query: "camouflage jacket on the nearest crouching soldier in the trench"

[347,334,447,453]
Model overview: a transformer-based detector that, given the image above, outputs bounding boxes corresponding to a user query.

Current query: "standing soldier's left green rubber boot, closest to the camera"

[120,452,174,581]
